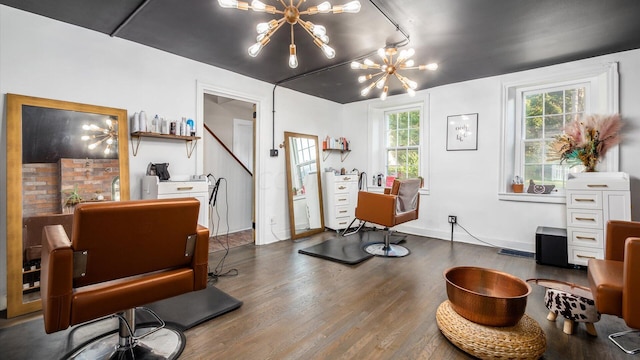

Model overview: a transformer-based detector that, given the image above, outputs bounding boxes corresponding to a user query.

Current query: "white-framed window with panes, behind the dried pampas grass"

[498,61,619,203]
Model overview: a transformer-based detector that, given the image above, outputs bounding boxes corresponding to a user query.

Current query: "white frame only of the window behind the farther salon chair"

[367,93,431,194]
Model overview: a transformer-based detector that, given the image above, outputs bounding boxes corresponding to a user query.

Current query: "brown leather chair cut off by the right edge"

[588,220,640,354]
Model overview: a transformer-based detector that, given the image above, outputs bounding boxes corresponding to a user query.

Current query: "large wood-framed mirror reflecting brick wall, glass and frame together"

[6,94,129,317]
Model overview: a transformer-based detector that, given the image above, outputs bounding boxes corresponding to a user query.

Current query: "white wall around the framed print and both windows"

[343,50,640,252]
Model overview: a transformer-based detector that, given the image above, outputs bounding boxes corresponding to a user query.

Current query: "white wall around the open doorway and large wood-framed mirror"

[0,5,341,309]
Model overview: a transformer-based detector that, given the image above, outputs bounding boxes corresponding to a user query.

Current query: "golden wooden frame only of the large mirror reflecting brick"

[6,94,129,318]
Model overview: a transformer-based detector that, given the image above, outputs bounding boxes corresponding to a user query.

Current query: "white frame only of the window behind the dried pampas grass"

[498,62,619,203]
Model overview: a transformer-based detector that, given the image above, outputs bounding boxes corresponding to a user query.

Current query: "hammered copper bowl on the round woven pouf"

[444,266,531,326]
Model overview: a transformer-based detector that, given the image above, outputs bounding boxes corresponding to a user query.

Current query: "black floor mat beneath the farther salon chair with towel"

[298,231,406,265]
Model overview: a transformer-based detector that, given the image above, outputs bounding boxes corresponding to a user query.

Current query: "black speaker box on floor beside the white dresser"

[536,226,569,268]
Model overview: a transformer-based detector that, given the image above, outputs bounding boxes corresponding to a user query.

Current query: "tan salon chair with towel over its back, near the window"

[356,179,422,257]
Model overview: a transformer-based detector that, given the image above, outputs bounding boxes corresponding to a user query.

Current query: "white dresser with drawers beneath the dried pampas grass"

[566,172,631,266]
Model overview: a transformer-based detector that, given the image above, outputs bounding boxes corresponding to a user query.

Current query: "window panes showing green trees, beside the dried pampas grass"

[521,85,586,188]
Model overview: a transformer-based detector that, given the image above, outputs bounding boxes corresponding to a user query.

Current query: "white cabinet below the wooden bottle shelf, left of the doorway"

[142,176,209,228]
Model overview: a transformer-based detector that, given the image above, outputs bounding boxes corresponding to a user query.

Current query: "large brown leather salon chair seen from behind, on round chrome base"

[41,198,209,359]
